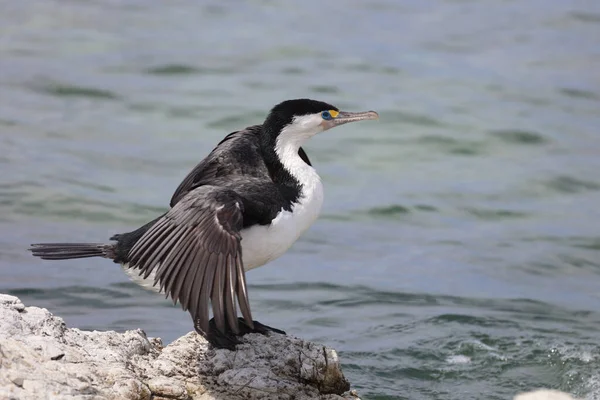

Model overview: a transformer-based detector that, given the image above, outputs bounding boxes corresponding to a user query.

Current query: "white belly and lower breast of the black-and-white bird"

[242,181,323,271]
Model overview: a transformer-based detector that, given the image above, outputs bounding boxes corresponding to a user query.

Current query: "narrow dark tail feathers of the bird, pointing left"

[29,243,114,260]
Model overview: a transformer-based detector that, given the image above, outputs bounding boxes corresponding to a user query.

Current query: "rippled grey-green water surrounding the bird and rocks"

[0,0,600,400]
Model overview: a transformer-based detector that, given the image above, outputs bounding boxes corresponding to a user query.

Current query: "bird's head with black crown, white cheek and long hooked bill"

[263,99,379,149]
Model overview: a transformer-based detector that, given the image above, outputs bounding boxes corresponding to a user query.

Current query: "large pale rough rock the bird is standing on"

[0,294,358,400]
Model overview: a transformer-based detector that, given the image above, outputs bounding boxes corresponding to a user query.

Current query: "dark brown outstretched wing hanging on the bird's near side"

[129,185,252,333]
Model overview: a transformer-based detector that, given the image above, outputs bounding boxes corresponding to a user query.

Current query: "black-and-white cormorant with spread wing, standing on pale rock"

[29,98,379,349]
